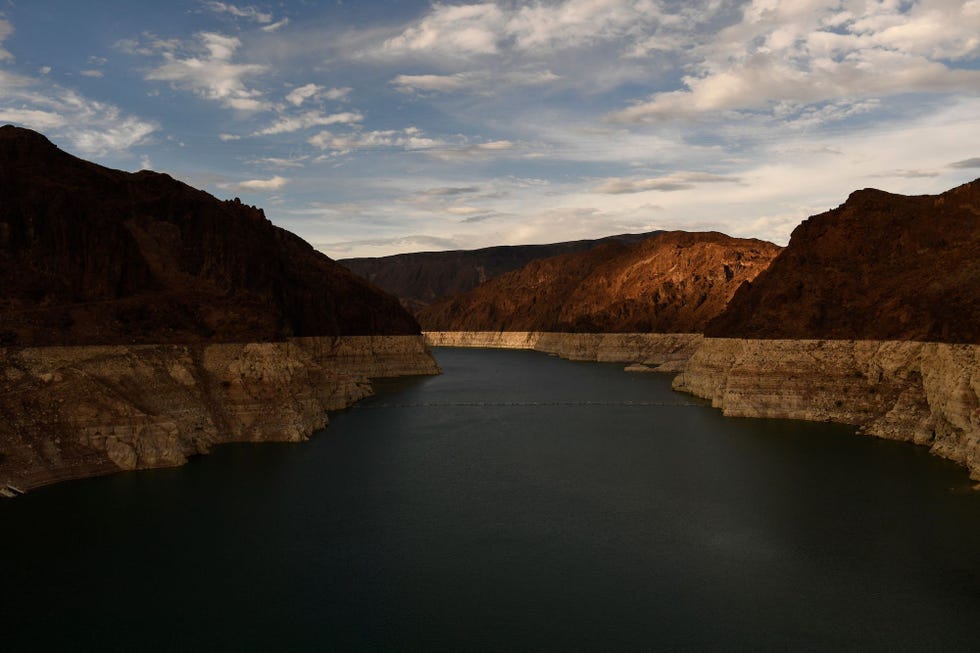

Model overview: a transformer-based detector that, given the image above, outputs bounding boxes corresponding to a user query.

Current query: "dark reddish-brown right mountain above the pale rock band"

[706,180,980,344]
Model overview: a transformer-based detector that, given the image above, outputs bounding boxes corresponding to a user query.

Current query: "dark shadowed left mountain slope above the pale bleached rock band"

[0,125,418,346]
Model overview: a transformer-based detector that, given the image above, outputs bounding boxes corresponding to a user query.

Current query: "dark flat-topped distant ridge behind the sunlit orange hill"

[337,233,652,311]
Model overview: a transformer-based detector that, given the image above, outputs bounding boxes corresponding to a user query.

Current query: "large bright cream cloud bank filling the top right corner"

[609,0,980,123]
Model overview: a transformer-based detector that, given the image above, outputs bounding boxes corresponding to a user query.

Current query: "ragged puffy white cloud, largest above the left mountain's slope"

[141,32,269,111]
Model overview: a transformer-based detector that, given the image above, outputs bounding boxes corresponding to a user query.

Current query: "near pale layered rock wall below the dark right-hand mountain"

[674,338,980,480]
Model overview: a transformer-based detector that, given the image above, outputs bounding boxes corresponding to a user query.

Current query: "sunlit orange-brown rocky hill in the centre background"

[417,231,780,333]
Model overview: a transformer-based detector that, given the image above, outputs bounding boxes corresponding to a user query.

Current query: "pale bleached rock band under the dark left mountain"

[0,336,439,494]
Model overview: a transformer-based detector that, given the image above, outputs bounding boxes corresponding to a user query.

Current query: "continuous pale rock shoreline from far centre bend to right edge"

[423,331,980,482]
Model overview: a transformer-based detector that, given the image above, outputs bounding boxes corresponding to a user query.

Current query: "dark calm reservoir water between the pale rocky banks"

[0,350,980,652]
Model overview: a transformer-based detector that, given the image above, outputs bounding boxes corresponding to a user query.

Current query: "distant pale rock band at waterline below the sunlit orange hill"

[424,331,703,372]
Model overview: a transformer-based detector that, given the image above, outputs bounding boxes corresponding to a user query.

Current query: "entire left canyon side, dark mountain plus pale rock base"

[0,126,439,495]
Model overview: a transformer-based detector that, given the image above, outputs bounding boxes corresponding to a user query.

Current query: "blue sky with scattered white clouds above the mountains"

[0,0,980,258]
